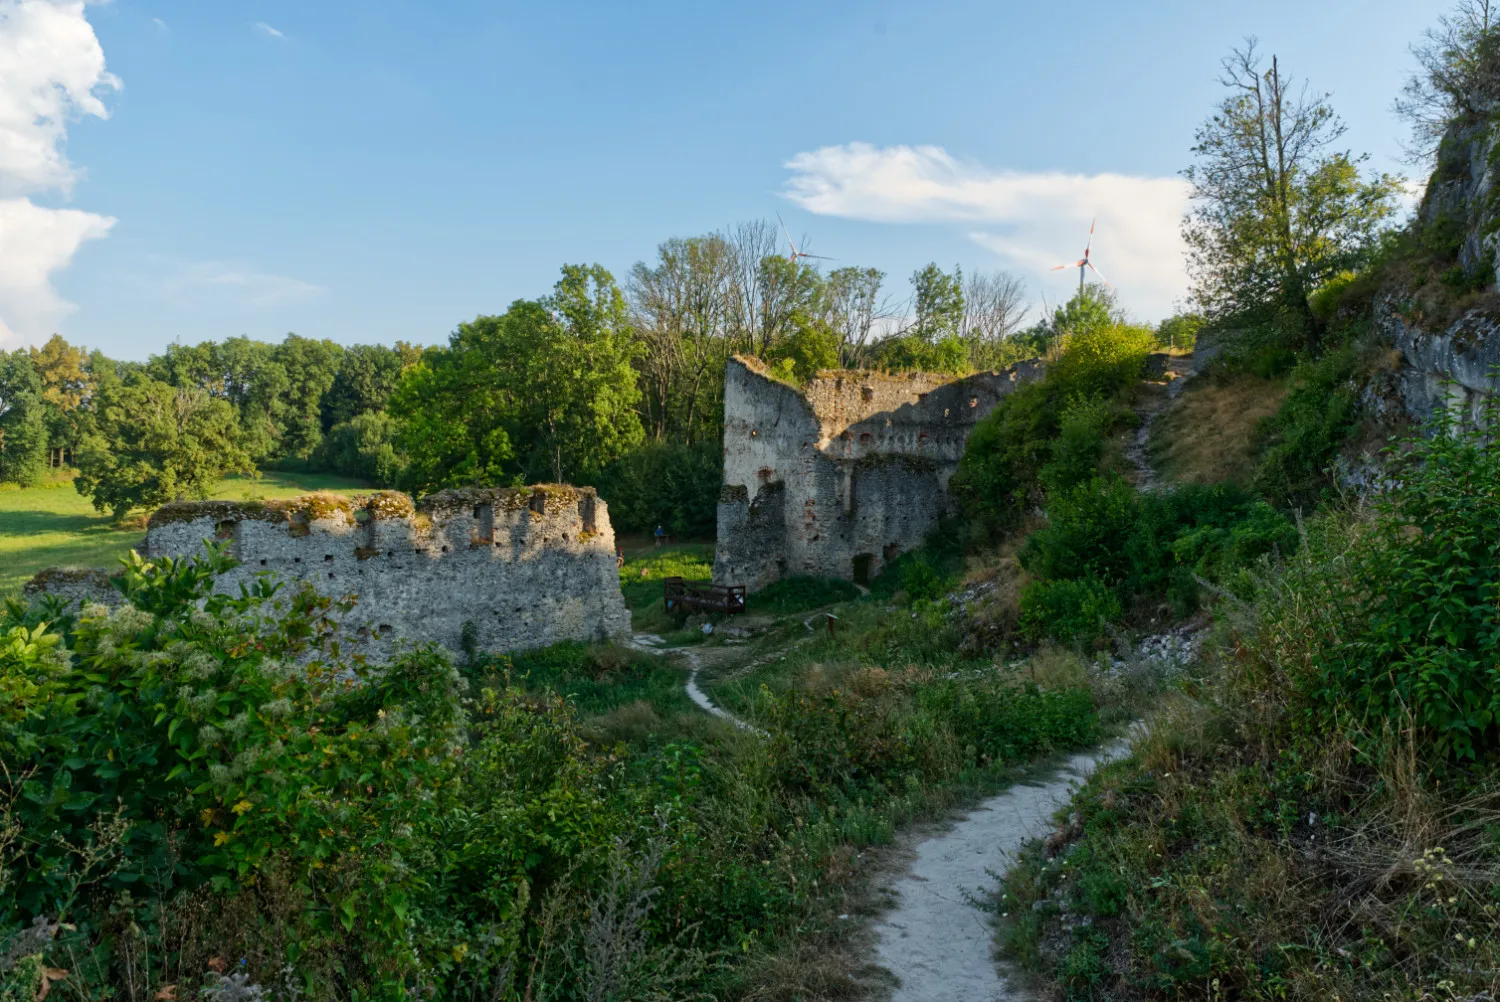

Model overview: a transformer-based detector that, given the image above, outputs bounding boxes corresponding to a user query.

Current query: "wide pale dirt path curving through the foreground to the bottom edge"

[875,743,1128,1002]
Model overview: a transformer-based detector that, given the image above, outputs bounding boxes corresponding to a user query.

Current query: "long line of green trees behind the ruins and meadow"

[0,222,1053,534]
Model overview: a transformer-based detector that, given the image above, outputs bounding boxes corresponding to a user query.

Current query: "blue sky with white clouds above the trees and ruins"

[0,0,1449,359]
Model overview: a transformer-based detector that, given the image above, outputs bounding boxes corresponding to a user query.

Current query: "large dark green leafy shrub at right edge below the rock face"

[1269,408,1500,759]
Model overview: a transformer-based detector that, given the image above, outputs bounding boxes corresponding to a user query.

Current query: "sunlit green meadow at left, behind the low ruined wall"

[0,473,365,596]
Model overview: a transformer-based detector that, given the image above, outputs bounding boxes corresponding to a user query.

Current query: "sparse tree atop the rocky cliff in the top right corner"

[1397,0,1500,161]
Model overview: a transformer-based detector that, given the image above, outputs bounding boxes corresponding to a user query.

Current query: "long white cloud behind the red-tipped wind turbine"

[783,143,1188,320]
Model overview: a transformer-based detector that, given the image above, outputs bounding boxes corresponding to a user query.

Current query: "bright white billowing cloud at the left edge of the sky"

[0,0,120,342]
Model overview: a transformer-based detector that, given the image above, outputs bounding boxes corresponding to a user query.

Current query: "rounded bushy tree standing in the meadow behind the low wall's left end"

[74,374,255,519]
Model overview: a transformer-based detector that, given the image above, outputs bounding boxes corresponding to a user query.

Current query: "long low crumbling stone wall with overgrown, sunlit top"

[146,486,630,659]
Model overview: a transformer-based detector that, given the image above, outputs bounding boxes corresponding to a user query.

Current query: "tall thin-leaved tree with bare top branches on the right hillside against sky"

[1182,39,1401,351]
